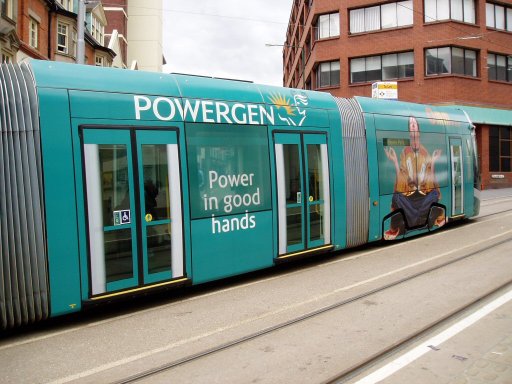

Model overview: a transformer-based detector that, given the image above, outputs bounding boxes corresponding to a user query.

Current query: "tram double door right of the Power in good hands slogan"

[274,133,331,256]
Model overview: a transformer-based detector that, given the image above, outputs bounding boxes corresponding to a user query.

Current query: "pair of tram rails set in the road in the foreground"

[111,237,512,384]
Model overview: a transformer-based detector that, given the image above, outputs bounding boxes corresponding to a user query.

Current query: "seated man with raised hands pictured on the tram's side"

[384,117,445,240]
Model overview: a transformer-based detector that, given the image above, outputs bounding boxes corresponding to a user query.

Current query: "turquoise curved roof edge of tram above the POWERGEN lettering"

[31,60,337,109]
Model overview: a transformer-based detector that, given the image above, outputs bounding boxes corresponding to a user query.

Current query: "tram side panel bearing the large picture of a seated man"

[374,114,450,240]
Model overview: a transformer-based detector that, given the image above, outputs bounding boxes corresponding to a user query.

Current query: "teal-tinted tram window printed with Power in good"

[187,124,270,219]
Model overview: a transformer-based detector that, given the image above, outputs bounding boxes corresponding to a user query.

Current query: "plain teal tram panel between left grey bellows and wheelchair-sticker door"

[38,88,81,316]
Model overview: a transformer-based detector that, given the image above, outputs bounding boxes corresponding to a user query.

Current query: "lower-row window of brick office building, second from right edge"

[425,47,477,77]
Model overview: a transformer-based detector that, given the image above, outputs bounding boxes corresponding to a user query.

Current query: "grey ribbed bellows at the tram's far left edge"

[0,64,49,329]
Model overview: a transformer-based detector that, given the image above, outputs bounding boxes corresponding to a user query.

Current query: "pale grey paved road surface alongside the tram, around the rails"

[0,190,512,383]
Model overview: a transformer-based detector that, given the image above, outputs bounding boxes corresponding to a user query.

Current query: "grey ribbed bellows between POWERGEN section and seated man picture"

[335,98,370,247]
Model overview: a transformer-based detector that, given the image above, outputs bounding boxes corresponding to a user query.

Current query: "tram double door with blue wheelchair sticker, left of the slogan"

[82,129,184,296]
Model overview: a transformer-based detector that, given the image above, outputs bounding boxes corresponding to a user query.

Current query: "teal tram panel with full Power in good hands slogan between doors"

[186,123,273,283]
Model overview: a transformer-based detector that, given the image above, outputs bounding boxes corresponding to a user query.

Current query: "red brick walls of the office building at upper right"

[284,0,512,108]
